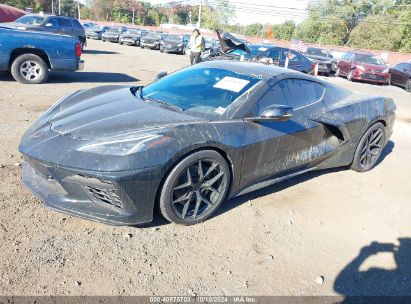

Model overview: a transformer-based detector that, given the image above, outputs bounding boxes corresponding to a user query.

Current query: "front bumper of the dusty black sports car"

[22,157,161,225]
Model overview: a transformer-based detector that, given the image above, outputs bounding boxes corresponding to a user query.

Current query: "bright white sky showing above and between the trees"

[149,0,308,25]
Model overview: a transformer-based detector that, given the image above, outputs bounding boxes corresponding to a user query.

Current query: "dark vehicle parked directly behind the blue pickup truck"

[1,14,87,47]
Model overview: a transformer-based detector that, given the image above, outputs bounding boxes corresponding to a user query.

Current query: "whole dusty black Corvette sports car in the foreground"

[20,61,396,225]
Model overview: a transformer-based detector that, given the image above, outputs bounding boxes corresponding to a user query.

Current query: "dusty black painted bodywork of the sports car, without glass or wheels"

[19,61,395,225]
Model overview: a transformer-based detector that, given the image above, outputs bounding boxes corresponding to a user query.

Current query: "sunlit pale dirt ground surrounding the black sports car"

[0,41,411,295]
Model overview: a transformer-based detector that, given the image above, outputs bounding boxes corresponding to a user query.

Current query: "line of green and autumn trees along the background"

[5,0,411,52]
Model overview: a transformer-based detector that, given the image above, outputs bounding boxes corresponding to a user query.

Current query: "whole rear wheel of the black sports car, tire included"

[351,122,387,172]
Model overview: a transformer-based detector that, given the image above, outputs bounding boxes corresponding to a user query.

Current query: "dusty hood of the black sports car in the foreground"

[48,86,200,140]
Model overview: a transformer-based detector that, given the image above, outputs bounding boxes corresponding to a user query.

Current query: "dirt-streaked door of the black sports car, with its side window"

[241,79,327,185]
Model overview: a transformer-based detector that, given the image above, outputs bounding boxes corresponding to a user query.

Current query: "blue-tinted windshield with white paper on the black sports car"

[141,66,261,117]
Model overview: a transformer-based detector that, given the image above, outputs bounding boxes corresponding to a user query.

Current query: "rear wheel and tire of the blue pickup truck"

[10,54,49,84]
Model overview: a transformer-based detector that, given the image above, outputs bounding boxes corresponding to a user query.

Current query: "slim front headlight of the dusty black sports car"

[77,134,163,156]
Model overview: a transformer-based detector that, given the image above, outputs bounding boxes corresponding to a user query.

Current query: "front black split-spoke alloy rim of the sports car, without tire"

[171,159,227,221]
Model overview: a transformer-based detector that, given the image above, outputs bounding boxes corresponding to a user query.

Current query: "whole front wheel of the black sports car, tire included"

[159,150,231,225]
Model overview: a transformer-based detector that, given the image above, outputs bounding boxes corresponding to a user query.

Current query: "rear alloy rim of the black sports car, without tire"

[360,128,384,170]
